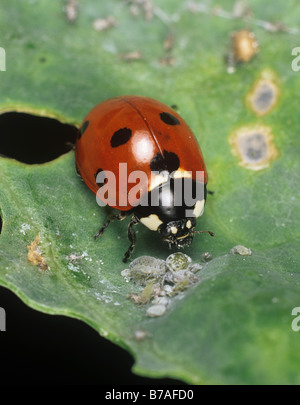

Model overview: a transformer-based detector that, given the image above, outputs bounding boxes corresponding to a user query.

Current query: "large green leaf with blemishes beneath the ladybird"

[0,0,300,384]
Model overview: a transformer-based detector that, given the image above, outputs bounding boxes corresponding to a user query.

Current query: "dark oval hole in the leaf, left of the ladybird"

[0,112,78,164]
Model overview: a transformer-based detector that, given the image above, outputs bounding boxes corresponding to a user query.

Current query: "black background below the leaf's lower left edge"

[0,287,182,385]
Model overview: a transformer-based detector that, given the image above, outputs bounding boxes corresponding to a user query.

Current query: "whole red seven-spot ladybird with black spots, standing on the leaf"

[75,96,213,262]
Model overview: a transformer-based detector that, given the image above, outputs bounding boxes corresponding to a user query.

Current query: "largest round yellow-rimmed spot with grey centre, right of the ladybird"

[229,125,278,170]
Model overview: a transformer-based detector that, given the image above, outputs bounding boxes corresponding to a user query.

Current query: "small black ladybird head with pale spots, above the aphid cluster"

[158,218,196,248]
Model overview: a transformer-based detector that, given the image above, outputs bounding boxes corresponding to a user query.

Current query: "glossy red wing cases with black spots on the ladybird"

[75,96,208,211]
